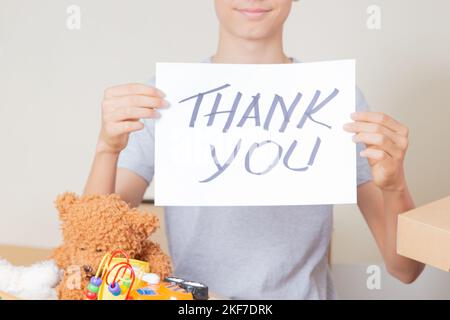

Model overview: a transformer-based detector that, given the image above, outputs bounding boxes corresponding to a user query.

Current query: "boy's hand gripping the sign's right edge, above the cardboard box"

[344,112,409,191]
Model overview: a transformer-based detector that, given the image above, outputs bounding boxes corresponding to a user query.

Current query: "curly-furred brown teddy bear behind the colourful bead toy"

[53,193,171,300]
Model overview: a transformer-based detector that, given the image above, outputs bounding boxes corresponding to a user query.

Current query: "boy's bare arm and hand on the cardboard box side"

[344,112,424,283]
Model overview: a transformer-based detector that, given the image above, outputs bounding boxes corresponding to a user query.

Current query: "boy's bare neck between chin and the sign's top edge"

[211,29,292,64]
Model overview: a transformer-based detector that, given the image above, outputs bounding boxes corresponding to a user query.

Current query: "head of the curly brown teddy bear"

[54,193,159,279]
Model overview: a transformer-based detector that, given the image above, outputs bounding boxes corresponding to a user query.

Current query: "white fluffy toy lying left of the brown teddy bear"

[0,258,60,300]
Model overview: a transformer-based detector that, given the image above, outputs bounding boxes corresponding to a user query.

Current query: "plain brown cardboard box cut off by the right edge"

[397,196,450,271]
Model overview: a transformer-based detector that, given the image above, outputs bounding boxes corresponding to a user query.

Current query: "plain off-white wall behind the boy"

[0,0,450,296]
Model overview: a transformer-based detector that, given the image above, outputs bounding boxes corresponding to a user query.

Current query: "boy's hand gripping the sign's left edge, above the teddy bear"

[97,83,168,154]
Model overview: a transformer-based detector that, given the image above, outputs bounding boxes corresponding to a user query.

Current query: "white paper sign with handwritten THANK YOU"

[155,60,356,206]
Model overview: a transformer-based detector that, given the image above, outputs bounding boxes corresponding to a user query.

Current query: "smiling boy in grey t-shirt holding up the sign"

[85,0,424,299]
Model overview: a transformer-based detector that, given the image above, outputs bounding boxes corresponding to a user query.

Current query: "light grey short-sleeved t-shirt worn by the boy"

[118,59,371,299]
